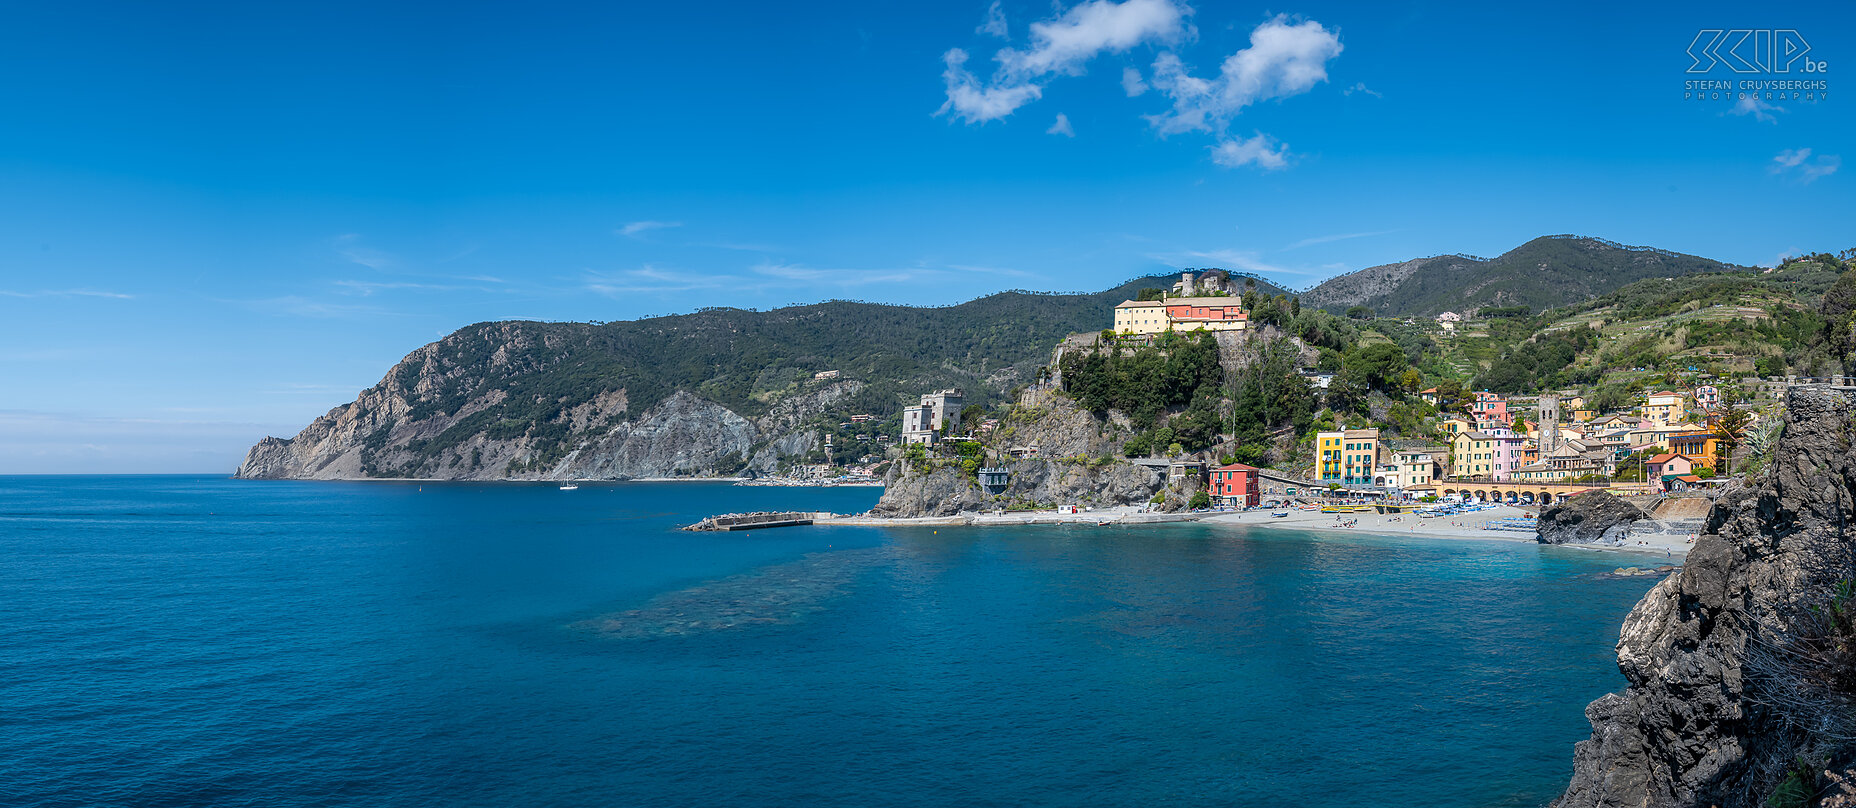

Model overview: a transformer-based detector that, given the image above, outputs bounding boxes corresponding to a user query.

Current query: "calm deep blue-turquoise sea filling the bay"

[0,477,1650,806]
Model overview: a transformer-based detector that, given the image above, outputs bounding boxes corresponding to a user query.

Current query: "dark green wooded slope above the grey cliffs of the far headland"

[373,275,1281,474]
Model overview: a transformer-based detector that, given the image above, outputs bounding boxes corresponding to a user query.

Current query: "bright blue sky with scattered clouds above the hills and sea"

[0,0,1856,474]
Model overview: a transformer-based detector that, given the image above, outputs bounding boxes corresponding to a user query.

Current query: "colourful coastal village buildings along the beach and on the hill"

[723,273,1849,542]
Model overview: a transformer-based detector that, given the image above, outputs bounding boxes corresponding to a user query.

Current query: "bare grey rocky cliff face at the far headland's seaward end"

[236,323,865,479]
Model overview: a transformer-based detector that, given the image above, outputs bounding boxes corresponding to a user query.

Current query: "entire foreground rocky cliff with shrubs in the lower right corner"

[1553,390,1856,808]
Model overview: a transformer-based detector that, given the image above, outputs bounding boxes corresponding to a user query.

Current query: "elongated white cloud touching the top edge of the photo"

[935,0,1192,124]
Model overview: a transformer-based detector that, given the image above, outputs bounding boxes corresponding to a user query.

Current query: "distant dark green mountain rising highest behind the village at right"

[1301,236,1743,318]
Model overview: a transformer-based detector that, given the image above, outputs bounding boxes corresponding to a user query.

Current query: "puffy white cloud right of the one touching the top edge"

[1149,15,1342,134]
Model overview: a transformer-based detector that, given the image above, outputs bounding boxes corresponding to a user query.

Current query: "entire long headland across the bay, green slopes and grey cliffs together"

[239,273,1282,479]
